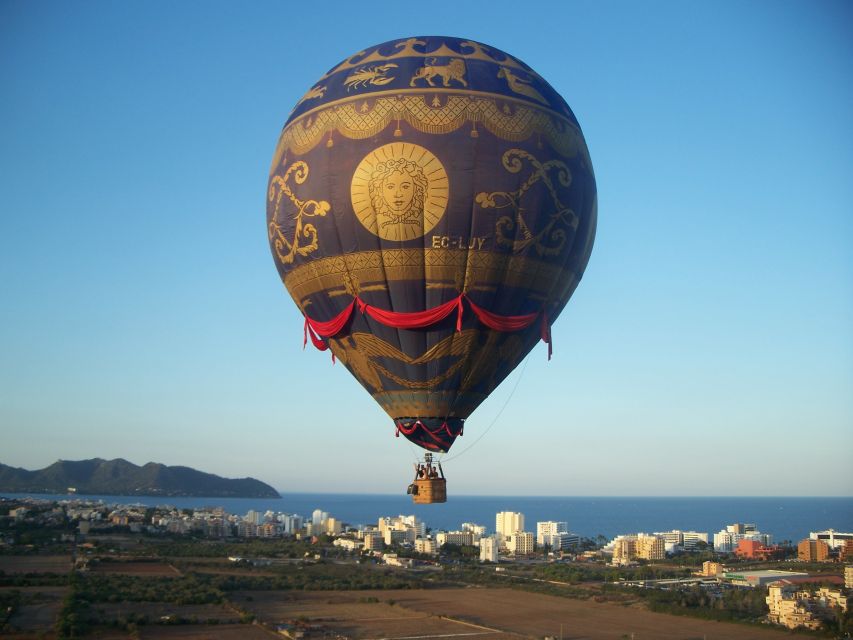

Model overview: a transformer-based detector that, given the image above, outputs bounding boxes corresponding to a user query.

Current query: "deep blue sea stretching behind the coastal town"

[0,493,853,543]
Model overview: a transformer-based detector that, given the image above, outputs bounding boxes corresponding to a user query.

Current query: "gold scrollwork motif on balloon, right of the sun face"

[475,149,578,256]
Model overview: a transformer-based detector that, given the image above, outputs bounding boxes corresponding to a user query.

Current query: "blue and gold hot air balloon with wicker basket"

[267,37,597,502]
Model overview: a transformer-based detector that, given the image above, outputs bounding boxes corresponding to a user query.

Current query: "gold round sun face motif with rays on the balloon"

[350,142,450,242]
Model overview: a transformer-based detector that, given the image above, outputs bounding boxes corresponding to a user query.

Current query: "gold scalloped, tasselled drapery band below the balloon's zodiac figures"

[273,90,591,169]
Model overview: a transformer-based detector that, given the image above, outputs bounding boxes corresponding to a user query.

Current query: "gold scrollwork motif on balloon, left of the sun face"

[267,160,330,264]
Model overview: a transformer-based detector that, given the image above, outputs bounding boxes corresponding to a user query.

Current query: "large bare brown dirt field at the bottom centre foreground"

[241,588,811,640]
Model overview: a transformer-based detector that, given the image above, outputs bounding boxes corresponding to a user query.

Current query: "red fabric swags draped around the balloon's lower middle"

[302,293,553,362]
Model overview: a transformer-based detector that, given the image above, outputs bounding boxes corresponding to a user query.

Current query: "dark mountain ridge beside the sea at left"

[0,458,281,498]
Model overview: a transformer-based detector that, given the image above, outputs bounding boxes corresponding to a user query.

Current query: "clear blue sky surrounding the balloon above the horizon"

[0,0,853,496]
